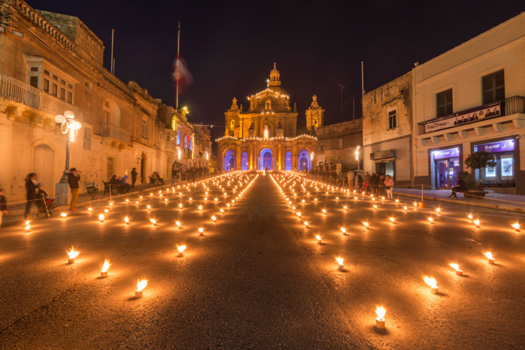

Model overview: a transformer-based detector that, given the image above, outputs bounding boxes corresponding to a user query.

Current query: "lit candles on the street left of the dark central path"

[49,173,258,298]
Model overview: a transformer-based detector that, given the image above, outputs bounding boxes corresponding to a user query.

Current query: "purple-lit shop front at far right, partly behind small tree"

[473,138,517,187]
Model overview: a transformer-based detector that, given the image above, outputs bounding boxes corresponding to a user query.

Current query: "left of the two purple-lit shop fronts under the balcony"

[430,146,462,189]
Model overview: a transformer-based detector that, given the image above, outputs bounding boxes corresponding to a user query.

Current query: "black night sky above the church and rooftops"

[34,0,525,139]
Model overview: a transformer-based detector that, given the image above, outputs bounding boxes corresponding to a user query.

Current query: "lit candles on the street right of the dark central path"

[272,174,520,328]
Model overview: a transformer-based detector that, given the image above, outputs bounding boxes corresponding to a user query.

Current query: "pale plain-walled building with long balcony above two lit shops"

[413,13,525,194]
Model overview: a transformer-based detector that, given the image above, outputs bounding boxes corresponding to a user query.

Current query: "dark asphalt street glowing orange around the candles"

[0,172,525,349]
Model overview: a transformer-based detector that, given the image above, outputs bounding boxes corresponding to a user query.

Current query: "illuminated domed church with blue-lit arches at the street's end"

[216,63,324,171]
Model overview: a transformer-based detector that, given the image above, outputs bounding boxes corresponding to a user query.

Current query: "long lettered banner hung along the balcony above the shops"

[425,102,501,132]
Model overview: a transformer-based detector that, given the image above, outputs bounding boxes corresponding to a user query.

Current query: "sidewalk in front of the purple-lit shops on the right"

[394,188,525,213]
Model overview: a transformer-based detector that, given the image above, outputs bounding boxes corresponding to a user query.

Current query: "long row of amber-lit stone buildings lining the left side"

[0,0,199,200]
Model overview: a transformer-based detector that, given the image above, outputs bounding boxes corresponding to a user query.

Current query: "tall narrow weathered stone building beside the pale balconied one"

[363,72,413,185]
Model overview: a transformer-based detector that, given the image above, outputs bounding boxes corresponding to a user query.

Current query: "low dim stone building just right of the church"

[314,119,363,172]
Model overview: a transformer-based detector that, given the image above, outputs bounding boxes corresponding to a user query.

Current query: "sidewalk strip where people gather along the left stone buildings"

[2,180,185,227]
